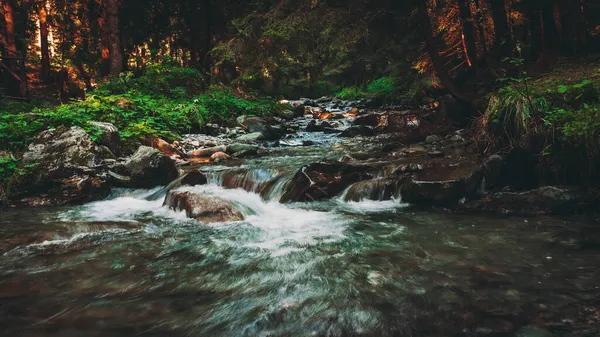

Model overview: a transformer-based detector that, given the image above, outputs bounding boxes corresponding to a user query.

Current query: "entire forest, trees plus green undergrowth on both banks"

[0,0,600,186]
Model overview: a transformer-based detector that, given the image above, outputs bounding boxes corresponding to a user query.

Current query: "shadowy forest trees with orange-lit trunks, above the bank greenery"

[0,0,600,99]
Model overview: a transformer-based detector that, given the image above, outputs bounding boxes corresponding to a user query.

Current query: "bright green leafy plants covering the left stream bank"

[0,65,282,156]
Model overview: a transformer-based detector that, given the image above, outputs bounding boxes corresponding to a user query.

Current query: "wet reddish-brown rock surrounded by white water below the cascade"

[164,188,244,224]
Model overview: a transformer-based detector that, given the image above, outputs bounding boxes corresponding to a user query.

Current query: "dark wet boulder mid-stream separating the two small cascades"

[281,162,373,202]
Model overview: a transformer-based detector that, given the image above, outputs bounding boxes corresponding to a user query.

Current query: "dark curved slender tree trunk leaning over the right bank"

[417,0,471,102]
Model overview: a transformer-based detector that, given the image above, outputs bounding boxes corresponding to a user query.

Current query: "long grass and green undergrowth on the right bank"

[476,57,600,182]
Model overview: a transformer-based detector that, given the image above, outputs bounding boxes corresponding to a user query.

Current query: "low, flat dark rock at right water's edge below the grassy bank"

[464,186,588,216]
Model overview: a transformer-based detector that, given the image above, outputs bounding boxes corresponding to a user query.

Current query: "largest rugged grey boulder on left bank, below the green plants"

[7,127,114,206]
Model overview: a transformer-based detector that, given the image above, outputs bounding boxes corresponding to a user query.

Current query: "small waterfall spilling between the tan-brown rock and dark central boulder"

[202,168,291,200]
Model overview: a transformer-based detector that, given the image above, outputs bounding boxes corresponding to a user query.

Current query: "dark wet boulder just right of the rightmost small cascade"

[401,164,483,206]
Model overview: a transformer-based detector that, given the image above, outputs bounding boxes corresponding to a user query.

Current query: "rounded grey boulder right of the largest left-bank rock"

[125,146,179,188]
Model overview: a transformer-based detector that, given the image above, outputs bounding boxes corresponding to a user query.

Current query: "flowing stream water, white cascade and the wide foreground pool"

[0,124,600,337]
